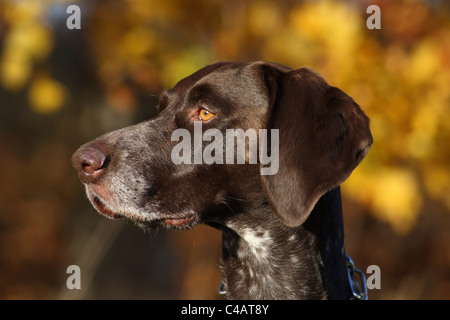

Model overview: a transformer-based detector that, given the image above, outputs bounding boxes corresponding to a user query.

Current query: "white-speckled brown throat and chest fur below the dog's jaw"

[222,228,322,299]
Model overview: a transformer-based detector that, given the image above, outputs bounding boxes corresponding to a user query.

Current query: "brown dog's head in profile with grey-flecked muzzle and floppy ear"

[72,62,372,228]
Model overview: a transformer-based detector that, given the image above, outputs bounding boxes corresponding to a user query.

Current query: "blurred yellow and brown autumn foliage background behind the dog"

[0,0,450,299]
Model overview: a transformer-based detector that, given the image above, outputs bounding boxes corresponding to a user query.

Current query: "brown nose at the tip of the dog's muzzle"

[72,145,110,183]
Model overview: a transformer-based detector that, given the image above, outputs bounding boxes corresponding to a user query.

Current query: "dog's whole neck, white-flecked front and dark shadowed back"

[207,188,351,299]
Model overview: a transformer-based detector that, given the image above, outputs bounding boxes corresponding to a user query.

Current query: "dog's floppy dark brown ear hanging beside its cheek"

[261,64,373,227]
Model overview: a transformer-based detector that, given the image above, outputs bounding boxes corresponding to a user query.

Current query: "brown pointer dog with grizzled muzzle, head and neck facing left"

[72,61,373,299]
